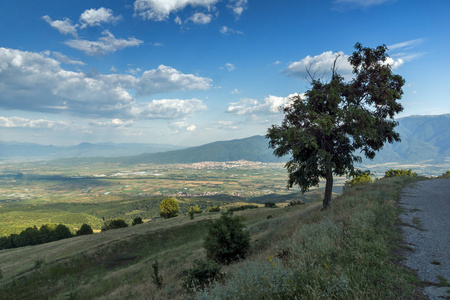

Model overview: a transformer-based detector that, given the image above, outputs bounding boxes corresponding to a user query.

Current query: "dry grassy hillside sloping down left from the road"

[0,178,422,299]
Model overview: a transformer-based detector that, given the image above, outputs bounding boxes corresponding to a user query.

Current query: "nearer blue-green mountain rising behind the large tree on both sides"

[120,114,450,163]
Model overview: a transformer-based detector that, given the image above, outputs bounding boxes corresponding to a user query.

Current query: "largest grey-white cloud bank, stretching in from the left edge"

[0,48,211,118]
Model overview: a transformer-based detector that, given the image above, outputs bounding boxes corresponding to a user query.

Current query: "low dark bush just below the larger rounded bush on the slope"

[183,260,223,291]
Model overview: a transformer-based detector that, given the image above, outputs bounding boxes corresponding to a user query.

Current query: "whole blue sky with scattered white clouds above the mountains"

[0,0,450,146]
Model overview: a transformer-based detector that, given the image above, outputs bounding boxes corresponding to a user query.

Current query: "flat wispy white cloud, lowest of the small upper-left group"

[64,30,143,55]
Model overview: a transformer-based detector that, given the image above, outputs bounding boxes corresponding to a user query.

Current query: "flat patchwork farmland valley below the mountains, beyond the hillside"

[0,161,345,235]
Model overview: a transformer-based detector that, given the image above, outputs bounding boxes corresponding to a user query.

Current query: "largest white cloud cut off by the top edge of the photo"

[134,0,219,21]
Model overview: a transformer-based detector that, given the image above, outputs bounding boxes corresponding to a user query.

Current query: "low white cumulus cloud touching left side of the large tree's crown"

[227,93,304,115]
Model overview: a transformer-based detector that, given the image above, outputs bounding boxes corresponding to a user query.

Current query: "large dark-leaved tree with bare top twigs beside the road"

[266,43,405,209]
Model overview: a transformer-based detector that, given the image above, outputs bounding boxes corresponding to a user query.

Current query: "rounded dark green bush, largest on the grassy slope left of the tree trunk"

[203,211,250,264]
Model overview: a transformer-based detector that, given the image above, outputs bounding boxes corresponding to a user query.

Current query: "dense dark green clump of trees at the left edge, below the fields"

[0,224,73,250]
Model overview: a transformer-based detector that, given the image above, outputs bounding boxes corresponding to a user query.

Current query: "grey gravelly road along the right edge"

[399,179,450,299]
